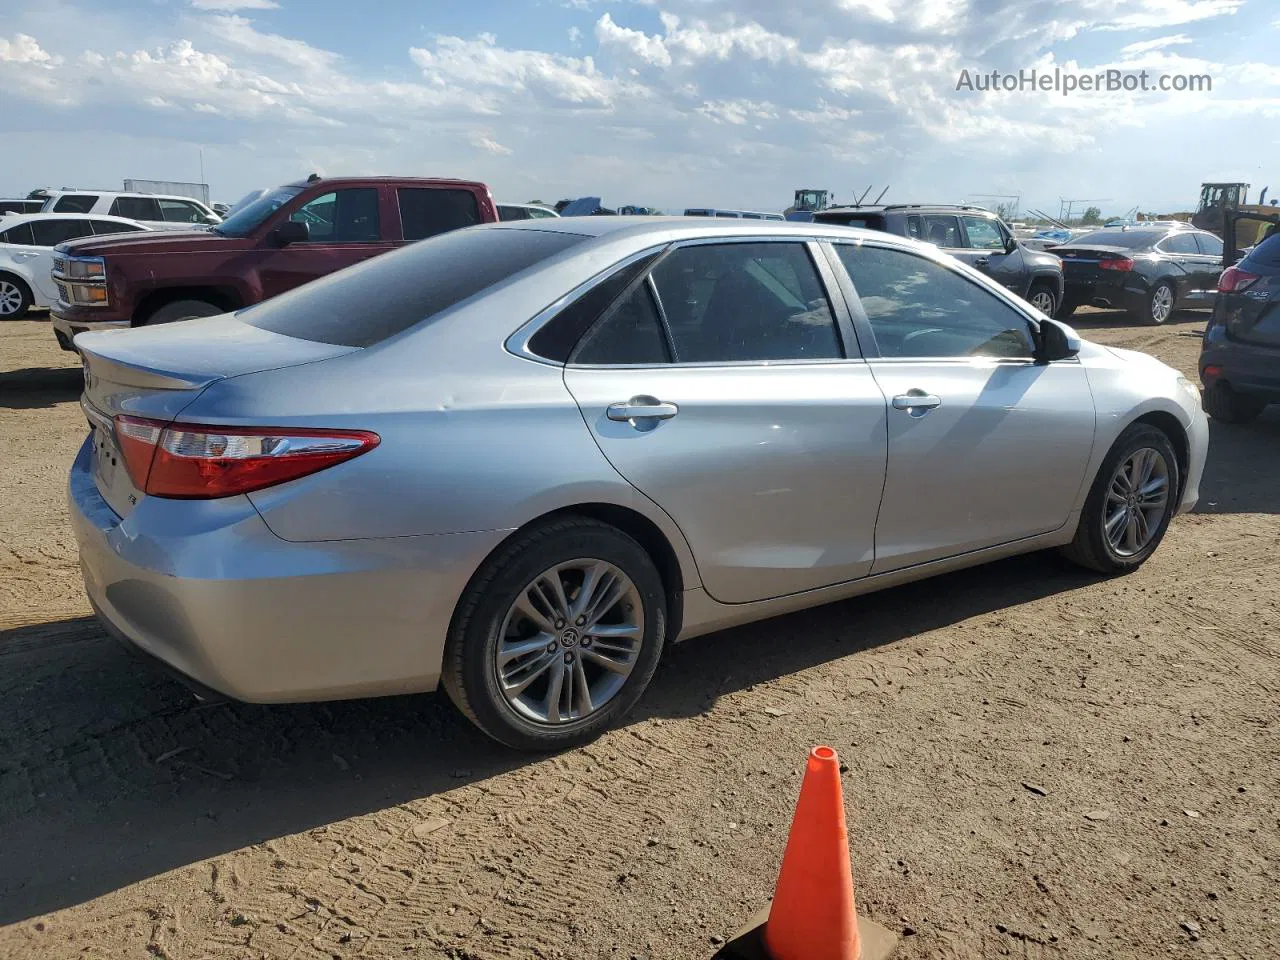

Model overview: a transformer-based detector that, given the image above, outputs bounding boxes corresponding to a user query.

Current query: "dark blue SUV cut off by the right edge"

[1199,233,1280,424]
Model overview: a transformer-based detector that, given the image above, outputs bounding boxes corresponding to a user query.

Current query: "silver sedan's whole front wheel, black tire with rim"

[1064,424,1181,573]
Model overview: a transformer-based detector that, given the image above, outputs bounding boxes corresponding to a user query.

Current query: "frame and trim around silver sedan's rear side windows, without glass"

[517,234,864,370]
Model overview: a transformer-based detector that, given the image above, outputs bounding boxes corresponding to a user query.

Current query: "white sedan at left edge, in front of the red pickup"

[0,214,151,320]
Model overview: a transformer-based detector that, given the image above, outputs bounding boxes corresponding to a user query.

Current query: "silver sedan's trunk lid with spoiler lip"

[76,316,360,517]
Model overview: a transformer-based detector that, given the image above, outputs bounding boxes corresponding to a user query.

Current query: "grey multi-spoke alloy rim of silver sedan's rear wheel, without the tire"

[493,558,644,726]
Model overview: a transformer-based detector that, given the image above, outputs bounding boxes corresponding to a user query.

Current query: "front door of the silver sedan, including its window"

[836,243,1094,573]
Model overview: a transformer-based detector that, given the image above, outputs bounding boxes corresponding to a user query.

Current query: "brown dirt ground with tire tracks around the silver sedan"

[0,312,1280,960]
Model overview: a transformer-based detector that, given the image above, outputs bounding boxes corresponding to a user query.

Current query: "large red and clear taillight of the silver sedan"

[115,416,379,499]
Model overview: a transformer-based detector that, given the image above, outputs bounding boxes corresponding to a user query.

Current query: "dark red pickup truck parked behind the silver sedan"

[51,175,498,349]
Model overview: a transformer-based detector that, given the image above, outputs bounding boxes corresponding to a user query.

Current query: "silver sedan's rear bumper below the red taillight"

[68,442,507,703]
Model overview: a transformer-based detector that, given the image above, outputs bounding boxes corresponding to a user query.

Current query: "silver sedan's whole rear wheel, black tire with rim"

[440,516,667,751]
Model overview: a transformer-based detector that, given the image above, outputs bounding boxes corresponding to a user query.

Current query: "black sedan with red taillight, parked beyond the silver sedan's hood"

[1053,225,1222,324]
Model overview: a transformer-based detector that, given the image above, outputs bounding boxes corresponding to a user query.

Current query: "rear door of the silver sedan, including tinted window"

[564,238,886,603]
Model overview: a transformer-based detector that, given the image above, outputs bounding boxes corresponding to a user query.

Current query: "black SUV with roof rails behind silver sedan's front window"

[813,204,1062,316]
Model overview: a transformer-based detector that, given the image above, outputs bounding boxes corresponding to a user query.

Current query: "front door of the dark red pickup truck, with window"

[259,187,396,297]
